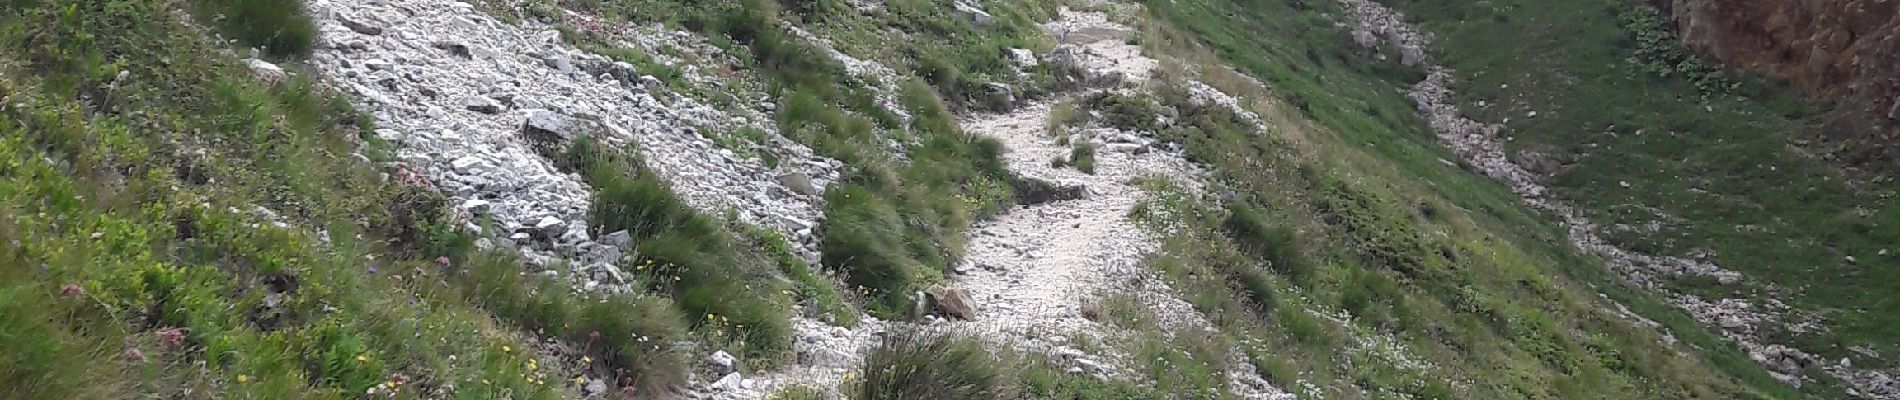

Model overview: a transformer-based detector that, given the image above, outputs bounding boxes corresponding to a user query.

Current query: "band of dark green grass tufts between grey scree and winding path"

[585,2,1011,317]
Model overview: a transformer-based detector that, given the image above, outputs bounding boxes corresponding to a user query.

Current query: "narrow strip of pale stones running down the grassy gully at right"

[1340,0,1900,398]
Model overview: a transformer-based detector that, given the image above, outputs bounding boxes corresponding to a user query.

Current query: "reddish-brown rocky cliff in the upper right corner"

[1653,0,1900,163]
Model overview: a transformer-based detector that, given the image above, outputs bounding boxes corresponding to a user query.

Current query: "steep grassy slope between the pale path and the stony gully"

[1142,2,1834,398]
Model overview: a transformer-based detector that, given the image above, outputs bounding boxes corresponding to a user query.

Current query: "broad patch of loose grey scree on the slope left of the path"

[310,0,842,269]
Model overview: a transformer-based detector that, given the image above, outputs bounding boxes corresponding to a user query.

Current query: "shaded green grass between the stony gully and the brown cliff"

[1393,0,1900,375]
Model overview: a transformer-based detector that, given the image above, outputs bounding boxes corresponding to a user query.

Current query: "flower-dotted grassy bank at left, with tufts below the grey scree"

[0,0,809,398]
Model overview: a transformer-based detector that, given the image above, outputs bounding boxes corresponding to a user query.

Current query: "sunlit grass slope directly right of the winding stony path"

[1096,2,1824,398]
